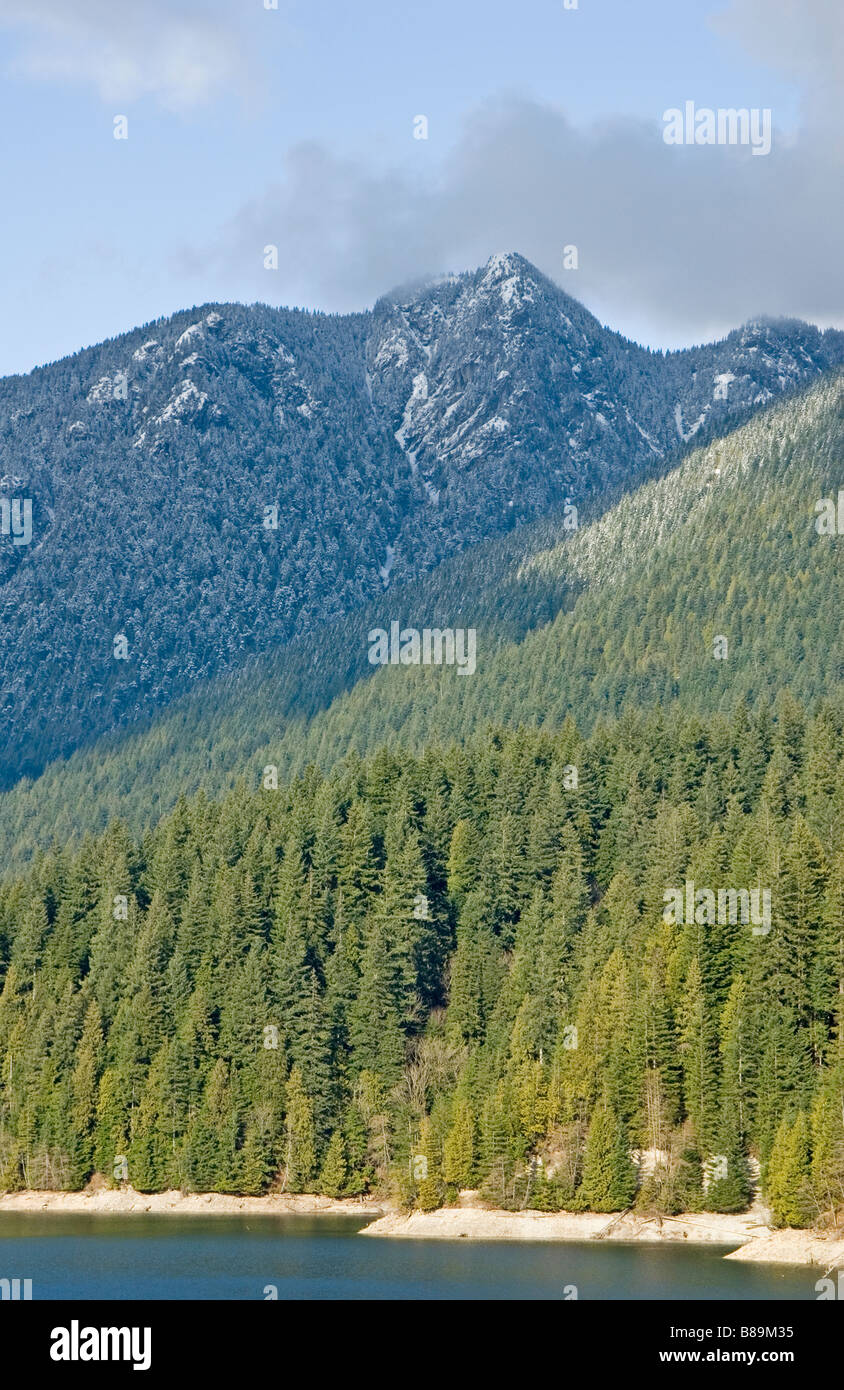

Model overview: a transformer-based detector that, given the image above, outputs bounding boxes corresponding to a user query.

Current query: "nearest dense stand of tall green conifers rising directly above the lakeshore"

[0,695,844,1225]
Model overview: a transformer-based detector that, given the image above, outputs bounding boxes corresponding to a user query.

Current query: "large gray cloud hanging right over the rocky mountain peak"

[210,97,844,343]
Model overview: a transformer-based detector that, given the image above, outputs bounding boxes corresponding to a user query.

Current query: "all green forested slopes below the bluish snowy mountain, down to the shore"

[0,378,844,1226]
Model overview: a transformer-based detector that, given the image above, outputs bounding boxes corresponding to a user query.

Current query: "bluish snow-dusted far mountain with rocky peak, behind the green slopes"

[0,254,844,785]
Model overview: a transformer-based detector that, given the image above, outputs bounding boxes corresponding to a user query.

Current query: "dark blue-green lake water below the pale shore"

[0,1212,822,1301]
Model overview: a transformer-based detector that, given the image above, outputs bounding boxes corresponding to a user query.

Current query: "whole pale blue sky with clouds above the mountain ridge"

[0,0,844,375]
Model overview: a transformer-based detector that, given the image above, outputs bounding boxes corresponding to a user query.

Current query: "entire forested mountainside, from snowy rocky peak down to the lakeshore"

[0,265,844,1226]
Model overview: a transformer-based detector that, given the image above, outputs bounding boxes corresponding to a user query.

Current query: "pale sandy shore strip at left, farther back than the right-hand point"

[0,1187,384,1218]
